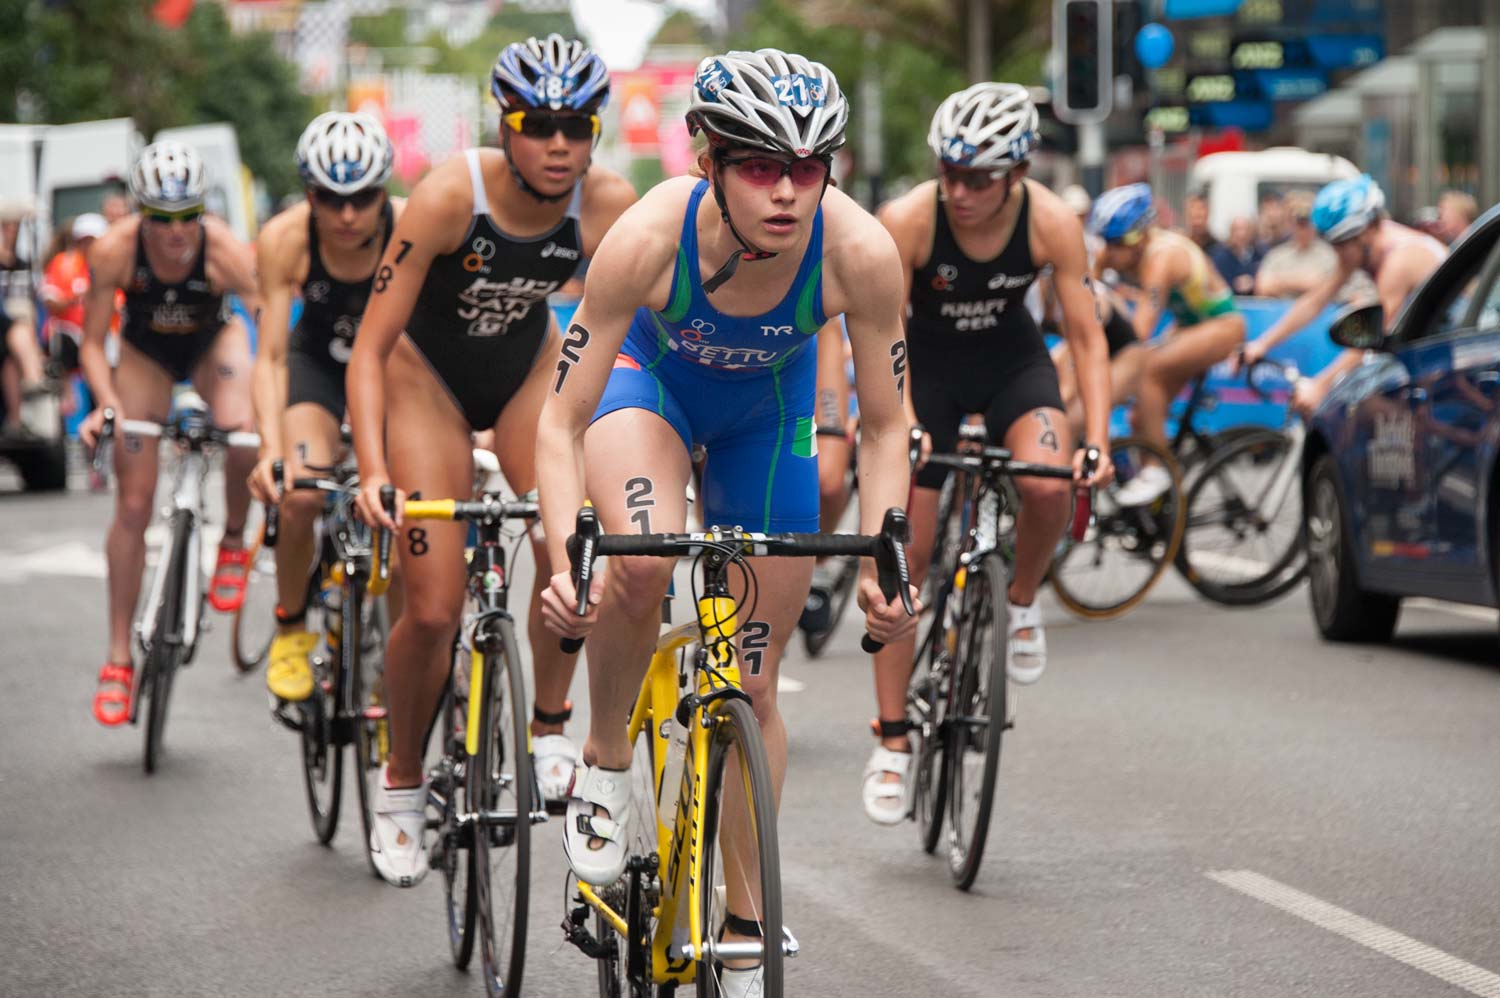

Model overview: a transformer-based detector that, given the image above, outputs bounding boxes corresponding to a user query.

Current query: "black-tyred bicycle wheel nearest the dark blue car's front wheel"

[1176,431,1307,606]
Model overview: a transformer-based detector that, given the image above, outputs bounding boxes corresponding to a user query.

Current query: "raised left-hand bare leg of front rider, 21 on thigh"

[584,408,692,770]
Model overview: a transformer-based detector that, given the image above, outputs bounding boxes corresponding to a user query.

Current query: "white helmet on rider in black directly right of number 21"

[927,83,1041,171]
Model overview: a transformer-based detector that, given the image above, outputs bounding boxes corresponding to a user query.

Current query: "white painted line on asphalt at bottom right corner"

[1205,870,1500,998]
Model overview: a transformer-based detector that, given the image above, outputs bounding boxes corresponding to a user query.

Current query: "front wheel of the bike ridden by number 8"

[468,617,536,998]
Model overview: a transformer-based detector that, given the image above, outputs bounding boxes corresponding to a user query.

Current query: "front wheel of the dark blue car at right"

[1304,455,1401,641]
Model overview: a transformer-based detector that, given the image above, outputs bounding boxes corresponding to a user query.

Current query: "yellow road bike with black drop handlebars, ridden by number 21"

[563,509,912,998]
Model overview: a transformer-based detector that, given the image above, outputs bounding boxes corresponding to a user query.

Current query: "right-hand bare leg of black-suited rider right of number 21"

[1005,408,1073,606]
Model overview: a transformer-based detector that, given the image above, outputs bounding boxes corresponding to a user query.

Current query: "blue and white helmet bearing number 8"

[489,33,609,111]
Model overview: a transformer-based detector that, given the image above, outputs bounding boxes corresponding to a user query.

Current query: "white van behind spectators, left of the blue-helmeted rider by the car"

[1188,146,1359,242]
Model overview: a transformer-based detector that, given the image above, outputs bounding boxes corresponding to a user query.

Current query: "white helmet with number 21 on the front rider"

[687,48,849,158]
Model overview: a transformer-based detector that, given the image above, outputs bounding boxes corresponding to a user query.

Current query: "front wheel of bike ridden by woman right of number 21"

[947,552,1007,890]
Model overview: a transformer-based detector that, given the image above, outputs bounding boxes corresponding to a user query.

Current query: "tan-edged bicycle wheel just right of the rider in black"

[1049,437,1187,620]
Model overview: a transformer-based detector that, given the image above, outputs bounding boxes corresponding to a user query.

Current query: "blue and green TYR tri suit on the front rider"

[594,180,828,531]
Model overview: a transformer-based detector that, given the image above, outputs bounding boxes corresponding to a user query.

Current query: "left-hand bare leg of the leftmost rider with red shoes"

[105,342,173,665]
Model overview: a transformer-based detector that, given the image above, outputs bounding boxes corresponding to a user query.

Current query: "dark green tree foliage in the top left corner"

[0,0,312,197]
